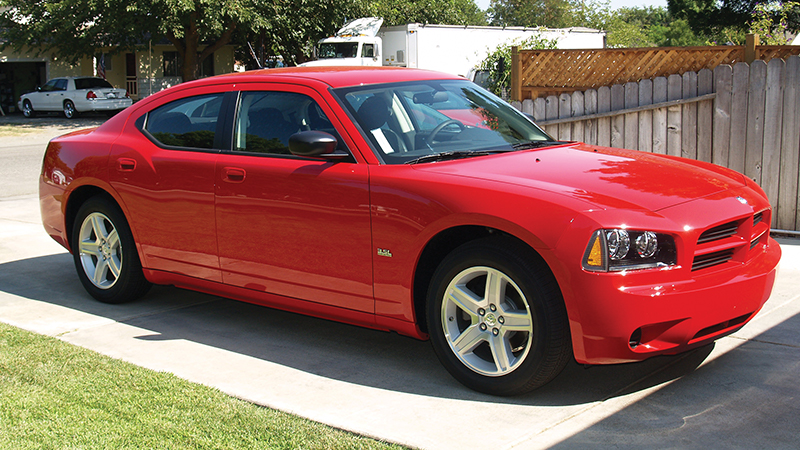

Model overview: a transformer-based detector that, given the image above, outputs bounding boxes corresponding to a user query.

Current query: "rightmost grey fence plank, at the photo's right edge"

[774,56,800,230]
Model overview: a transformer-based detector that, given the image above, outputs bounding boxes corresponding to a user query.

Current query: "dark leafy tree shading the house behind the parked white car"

[0,0,264,81]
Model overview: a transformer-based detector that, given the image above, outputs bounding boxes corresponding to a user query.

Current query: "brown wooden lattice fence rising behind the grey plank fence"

[511,42,800,100]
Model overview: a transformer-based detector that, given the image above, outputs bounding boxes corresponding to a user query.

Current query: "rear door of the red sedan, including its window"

[109,87,226,282]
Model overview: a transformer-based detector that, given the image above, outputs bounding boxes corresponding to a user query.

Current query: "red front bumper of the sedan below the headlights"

[570,238,781,364]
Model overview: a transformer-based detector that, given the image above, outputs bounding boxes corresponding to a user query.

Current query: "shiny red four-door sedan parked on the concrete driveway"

[40,68,781,395]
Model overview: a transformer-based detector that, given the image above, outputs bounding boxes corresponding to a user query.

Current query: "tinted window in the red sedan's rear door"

[144,93,224,149]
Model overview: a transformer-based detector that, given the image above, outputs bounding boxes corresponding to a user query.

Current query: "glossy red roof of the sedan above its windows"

[197,66,464,88]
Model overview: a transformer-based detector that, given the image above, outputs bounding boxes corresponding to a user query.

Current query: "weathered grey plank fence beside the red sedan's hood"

[514,56,800,231]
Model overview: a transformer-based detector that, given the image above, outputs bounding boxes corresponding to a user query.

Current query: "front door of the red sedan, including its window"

[216,84,374,313]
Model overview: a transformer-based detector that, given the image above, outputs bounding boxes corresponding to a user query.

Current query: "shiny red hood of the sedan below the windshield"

[414,144,745,211]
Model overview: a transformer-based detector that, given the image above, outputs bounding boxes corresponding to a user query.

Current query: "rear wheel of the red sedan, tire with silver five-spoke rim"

[71,197,151,303]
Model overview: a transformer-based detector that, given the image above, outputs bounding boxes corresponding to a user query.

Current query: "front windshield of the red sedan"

[334,80,553,164]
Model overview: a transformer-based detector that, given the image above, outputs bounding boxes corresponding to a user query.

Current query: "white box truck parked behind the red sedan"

[303,17,606,76]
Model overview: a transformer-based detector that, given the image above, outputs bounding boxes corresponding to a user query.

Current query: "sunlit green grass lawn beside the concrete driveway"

[0,323,402,450]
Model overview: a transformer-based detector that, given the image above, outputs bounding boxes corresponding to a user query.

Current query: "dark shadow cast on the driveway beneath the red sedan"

[0,253,713,406]
